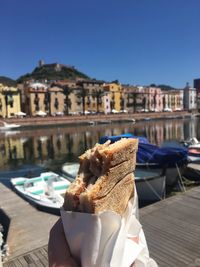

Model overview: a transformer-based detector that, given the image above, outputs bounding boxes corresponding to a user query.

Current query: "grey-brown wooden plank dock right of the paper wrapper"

[140,187,200,267]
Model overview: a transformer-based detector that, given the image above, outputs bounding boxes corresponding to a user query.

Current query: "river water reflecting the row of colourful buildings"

[0,118,200,173]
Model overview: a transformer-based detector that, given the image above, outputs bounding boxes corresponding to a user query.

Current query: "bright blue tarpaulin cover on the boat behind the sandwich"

[100,133,188,168]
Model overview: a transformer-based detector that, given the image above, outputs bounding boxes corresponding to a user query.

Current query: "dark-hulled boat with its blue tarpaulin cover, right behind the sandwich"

[99,133,188,187]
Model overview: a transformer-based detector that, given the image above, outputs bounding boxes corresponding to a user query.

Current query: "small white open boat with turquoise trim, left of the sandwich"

[10,172,70,212]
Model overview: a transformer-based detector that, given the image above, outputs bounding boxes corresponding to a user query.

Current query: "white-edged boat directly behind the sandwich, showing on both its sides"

[62,163,166,203]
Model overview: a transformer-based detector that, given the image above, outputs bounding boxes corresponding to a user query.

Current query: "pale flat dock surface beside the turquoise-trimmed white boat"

[0,183,58,260]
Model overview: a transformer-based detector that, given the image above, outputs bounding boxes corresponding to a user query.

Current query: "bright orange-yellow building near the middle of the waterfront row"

[104,83,124,112]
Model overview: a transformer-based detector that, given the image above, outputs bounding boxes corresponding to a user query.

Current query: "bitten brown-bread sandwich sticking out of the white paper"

[63,138,138,215]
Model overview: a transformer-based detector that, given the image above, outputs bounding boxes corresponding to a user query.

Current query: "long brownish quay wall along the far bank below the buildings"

[2,111,199,127]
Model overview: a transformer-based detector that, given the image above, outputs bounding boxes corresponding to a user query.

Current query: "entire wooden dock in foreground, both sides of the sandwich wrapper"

[0,183,200,267]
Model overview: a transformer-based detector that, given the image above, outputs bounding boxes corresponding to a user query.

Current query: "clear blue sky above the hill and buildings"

[0,0,200,88]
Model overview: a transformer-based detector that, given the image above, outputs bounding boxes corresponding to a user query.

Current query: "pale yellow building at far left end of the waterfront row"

[0,84,21,118]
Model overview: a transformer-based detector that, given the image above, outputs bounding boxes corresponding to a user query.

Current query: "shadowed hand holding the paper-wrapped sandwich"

[48,219,78,267]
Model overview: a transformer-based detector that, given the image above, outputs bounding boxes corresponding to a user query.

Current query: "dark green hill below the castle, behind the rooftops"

[17,63,89,83]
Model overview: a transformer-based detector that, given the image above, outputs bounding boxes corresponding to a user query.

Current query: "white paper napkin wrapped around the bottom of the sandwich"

[61,188,157,267]
